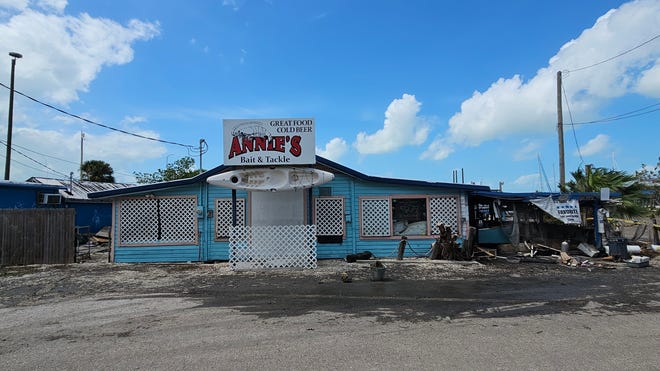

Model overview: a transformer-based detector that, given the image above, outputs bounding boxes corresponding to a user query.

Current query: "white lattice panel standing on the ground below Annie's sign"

[229,224,316,270]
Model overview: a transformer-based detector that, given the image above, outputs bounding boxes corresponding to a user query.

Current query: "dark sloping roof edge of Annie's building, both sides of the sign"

[89,156,490,198]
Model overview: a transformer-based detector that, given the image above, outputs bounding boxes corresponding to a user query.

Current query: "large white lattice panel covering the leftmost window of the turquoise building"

[119,197,197,245]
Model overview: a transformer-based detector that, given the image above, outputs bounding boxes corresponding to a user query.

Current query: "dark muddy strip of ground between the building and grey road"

[0,254,660,321]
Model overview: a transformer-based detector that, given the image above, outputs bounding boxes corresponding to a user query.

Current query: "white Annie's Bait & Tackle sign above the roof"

[223,118,316,166]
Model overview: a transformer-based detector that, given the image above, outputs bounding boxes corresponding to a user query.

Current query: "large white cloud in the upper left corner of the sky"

[0,2,160,104]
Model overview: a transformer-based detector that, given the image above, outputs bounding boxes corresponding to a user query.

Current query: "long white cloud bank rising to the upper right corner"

[429,0,660,158]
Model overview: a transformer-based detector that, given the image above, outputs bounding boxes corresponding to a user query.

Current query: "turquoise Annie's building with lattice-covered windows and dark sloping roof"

[89,156,490,266]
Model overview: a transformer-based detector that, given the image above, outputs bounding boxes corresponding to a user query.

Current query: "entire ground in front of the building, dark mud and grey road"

[0,256,660,370]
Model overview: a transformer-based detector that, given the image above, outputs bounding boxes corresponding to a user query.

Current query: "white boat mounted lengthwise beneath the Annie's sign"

[206,167,335,192]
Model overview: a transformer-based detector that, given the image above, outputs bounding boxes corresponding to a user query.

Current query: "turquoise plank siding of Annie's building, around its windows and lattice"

[113,174,467,262]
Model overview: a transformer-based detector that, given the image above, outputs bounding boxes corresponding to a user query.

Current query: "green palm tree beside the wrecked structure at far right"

[561,165,648,217]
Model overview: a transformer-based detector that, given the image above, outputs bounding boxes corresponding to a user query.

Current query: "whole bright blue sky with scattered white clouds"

[0,0,660,192]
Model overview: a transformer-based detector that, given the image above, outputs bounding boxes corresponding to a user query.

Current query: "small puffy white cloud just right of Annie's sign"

[353,94,430,154]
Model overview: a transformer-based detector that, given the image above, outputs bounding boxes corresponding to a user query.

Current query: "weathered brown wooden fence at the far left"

[0,208,76,265]
